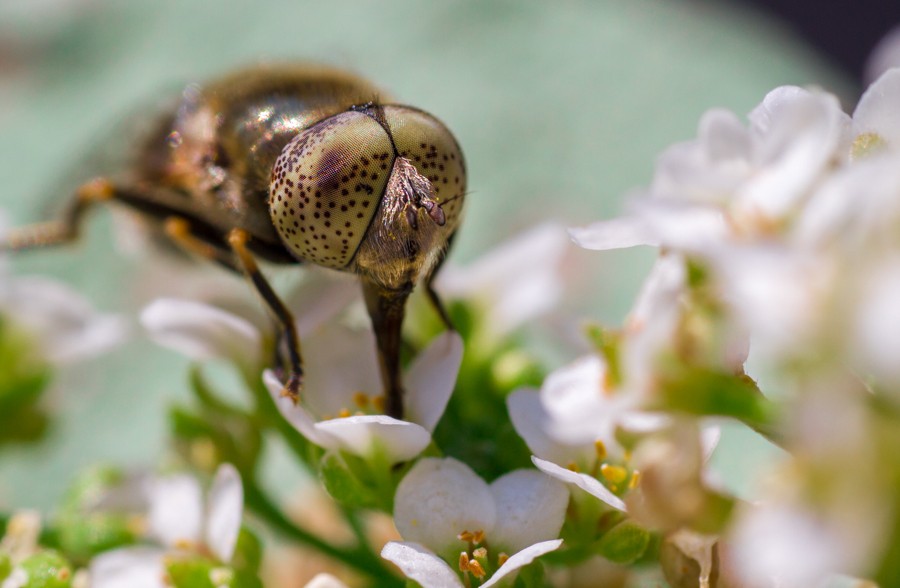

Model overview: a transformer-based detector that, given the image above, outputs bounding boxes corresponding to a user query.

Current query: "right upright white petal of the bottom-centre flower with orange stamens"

[488,470,569,553]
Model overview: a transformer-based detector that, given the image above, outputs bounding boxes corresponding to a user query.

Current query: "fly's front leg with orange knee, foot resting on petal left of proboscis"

[228,229,303,402]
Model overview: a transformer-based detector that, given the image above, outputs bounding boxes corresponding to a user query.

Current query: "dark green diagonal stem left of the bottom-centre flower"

[244,480,403,587]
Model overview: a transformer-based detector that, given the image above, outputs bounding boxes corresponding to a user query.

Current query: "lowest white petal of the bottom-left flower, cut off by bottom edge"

[90,547,167,588]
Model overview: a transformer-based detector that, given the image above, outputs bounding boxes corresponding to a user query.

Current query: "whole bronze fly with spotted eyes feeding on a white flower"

[4,65,466,418]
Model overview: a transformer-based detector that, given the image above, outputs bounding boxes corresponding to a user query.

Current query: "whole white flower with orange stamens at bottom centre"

[381,458,569,588]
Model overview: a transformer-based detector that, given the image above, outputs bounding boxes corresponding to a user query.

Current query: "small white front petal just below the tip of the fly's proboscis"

[315,415,431,464]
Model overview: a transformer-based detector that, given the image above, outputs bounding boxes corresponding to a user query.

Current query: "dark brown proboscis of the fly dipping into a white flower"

[362,278,412,419]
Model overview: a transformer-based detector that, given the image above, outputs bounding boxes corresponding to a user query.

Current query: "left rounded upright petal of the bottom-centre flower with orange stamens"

[394,457,497,555]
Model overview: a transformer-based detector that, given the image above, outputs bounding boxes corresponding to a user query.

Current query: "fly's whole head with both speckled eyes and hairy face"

[269,106,464,290]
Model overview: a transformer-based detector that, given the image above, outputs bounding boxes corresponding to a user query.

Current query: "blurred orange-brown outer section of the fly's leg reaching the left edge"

[0,178,116,251]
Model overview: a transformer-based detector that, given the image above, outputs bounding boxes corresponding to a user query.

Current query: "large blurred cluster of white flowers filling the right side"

[572,69,900,586]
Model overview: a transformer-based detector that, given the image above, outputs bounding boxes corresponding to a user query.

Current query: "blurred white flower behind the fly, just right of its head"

[437,224,569,336]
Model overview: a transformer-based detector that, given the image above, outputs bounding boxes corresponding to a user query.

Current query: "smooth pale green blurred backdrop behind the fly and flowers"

[0,0,857,510]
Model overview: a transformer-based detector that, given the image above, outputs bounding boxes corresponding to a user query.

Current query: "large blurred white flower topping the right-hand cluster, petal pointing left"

[571,86,849,255]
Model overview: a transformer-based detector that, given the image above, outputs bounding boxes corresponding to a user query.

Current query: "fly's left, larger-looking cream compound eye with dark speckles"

[269,111,394,269]
